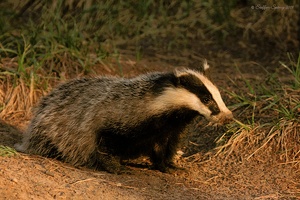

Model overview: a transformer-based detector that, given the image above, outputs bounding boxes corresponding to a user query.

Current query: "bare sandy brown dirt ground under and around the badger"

[0,53,300,200]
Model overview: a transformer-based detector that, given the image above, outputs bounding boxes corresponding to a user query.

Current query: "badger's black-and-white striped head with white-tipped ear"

[154,61,233,124]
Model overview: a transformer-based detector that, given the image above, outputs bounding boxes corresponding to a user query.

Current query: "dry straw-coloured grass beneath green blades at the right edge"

[215,119,300,168]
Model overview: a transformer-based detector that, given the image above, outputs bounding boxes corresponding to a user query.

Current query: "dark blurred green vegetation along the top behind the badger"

[0,0,300,78]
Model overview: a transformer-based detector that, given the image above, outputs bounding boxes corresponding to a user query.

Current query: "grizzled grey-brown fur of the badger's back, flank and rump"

[19,73,182,165]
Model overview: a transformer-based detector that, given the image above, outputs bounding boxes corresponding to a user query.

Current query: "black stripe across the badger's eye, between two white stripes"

[179,74,220,115]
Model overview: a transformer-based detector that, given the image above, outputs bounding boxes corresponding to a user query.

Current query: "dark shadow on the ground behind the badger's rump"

[0,120,22,148]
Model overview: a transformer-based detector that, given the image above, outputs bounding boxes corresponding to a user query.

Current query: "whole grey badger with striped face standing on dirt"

[15,63,233,173]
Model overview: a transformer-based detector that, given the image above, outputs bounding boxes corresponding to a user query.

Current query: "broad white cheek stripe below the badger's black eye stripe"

[150,88,211,118]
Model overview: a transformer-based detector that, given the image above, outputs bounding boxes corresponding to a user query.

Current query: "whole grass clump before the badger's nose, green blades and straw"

[216,56,300,167]
